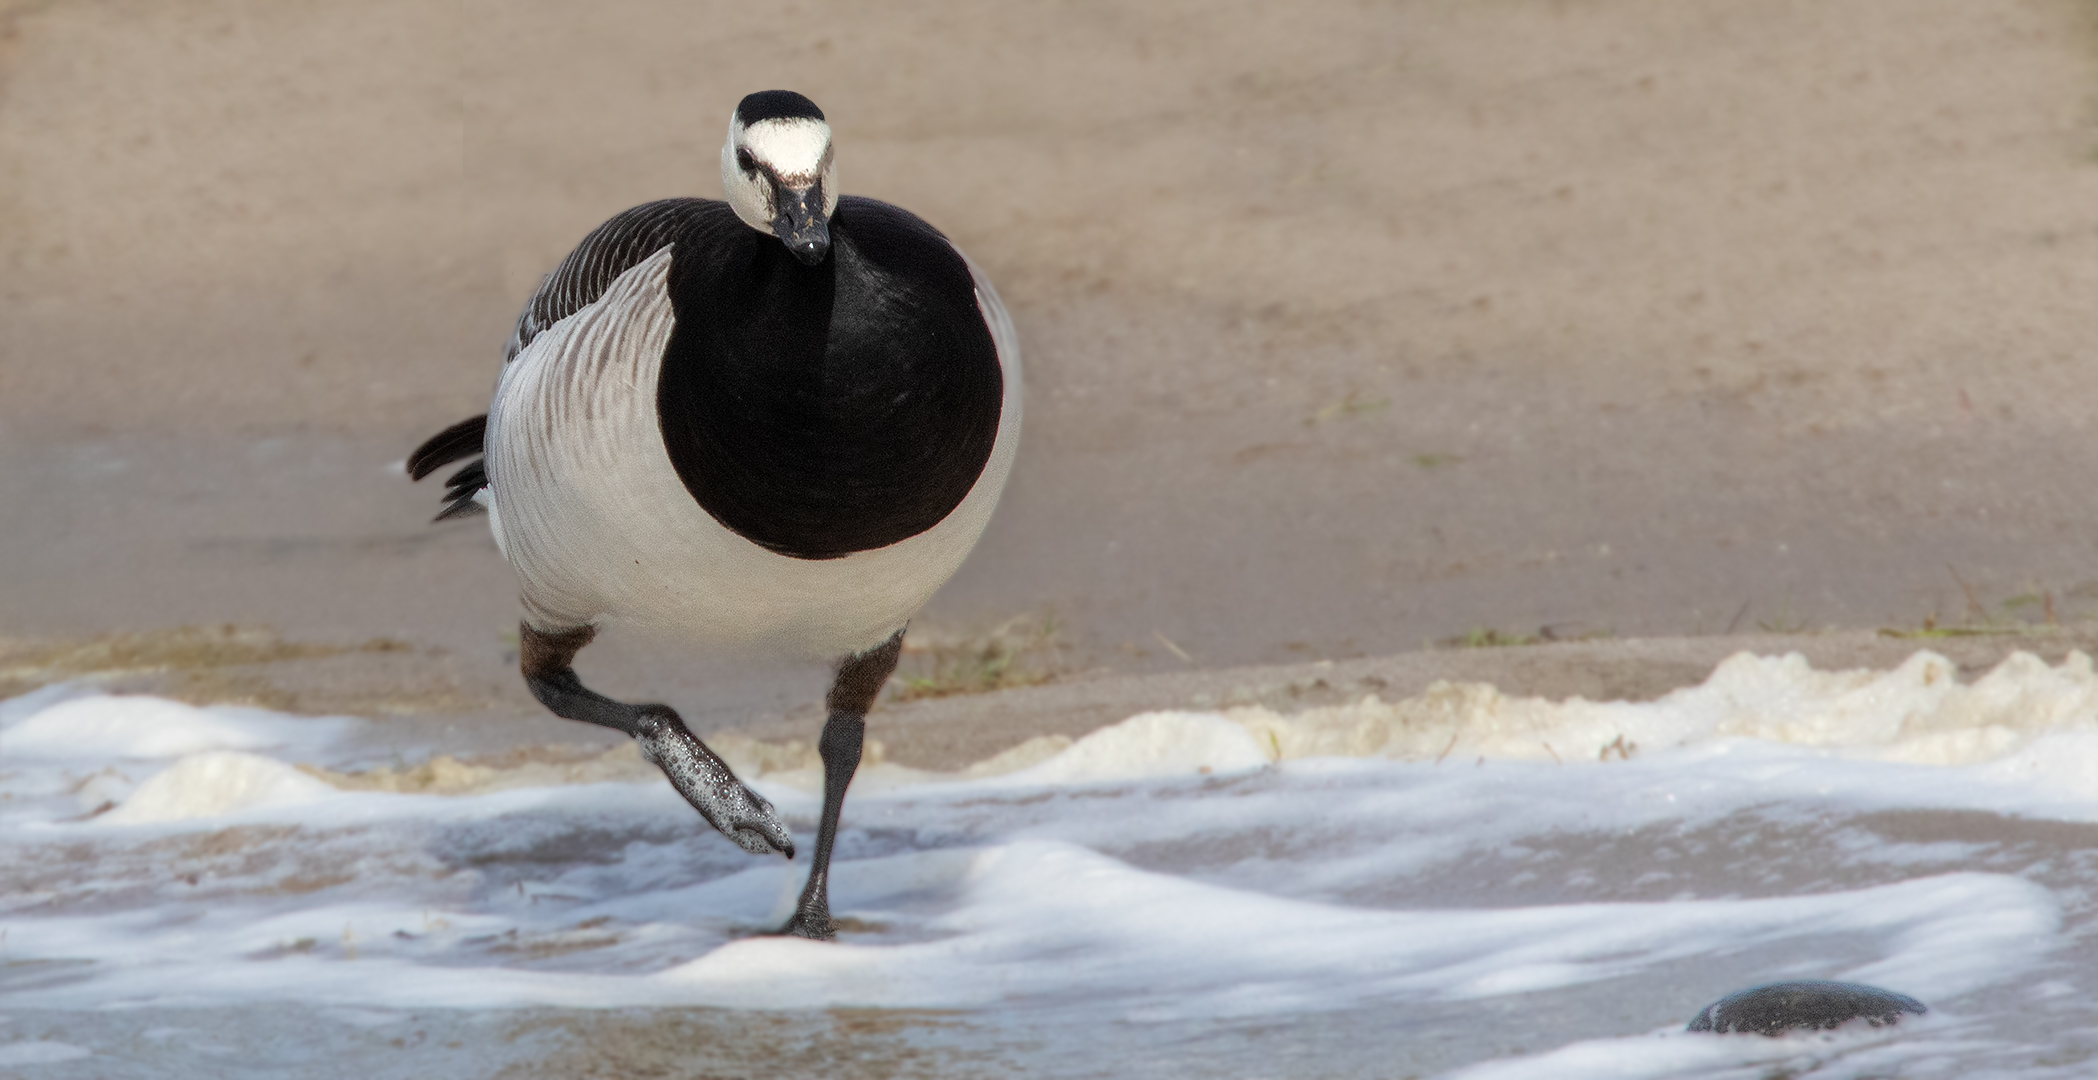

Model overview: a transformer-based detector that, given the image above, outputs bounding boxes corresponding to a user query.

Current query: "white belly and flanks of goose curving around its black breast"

[487,247,1020,658]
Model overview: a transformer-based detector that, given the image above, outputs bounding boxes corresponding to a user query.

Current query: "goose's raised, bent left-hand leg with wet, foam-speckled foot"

[518,623,793,858]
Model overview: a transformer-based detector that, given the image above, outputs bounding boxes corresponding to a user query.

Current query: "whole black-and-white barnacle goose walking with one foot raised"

[409,90,1020,937]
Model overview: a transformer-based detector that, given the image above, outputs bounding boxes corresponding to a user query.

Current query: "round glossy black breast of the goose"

[657,197,1005,558]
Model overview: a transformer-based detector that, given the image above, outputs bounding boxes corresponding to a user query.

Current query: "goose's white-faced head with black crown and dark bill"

[722,90,837,266]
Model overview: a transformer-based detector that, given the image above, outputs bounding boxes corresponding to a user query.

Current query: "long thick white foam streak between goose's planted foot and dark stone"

[641,841,2060,1019]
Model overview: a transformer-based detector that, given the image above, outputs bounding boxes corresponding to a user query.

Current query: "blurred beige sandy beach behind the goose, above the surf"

[0,0,2098,723]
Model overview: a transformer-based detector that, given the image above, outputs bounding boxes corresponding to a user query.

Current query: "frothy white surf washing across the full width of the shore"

[12,652,2098,1078]
